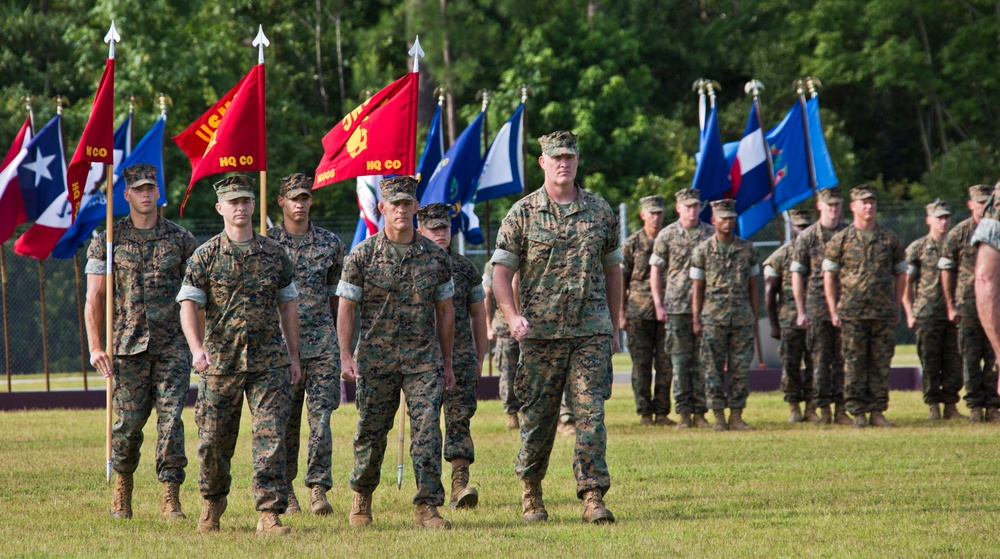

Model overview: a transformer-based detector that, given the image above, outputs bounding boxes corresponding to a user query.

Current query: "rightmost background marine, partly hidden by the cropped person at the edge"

[938,184,1000,423]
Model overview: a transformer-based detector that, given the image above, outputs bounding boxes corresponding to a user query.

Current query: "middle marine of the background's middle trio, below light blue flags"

[790,188,853,425]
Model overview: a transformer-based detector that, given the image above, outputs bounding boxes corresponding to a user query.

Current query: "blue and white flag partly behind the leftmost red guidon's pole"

[52,117,132,259]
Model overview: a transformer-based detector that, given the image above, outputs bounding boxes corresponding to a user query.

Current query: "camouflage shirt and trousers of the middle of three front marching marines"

[337,231,457,506]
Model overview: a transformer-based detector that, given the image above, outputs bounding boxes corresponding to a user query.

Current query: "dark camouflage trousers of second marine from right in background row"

[916,319,964,404]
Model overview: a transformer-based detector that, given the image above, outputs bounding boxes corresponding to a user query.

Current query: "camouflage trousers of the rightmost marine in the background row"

[958,316,1000,408]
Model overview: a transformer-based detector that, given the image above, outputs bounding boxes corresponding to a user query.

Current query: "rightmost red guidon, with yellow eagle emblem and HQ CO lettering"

[313,72,420,190]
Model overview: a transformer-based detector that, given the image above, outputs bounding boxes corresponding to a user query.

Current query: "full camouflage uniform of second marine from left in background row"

[649,221,715,414]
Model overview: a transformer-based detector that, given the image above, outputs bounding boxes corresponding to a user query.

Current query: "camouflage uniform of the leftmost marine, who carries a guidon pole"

[86,217,198,483]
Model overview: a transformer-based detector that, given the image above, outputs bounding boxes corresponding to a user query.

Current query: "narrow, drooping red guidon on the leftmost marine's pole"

[66,58,115,220]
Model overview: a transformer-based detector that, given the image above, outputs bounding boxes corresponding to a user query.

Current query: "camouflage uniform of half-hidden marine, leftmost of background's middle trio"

[764,242,813,404]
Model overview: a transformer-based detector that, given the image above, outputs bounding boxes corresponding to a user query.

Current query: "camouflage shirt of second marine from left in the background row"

[649,219,715,316]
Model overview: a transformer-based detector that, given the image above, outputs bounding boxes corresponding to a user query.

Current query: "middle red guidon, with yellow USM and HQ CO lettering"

[173,64,267,215]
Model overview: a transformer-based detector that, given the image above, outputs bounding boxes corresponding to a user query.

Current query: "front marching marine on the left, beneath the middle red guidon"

[177,175,300,534]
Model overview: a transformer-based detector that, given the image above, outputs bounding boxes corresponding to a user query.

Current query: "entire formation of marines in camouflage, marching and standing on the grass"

[86,132,1000,535]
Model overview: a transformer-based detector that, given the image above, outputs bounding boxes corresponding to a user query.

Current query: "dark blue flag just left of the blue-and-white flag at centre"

[420,113,484,244]
